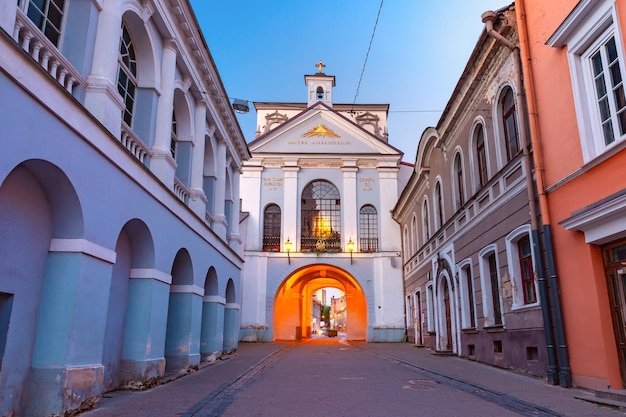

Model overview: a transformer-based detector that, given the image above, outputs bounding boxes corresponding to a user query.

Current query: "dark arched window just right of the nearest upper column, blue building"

[117,23,137,127]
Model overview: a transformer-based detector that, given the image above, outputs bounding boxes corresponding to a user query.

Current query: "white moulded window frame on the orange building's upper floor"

[547,0,626,163]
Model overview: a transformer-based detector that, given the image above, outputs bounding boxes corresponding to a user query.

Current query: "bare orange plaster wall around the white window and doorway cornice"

[518,0,626,389]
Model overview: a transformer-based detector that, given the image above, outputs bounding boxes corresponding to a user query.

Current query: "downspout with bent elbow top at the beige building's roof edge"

[481,11,559,385]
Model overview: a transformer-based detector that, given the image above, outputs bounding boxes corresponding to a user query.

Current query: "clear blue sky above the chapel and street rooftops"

[190,0,511,163]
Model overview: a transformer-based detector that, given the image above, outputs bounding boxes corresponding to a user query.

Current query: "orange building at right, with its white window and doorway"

[516,0,626,389]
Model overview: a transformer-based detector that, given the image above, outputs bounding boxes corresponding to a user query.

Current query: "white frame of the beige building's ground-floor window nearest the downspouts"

[505,224,541,310]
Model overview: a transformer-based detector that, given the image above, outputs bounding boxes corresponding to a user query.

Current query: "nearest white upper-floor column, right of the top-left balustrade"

[83,0,124,138]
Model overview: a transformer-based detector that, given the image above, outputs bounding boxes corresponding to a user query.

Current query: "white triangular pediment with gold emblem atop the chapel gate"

[248,106,401,155]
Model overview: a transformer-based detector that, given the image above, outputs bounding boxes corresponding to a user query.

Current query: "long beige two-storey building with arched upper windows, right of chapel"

[393,4,549,376]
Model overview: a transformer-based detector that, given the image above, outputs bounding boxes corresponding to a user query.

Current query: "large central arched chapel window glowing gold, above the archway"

[300,180,341,252]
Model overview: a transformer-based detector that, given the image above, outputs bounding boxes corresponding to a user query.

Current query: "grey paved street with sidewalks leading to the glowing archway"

[81,337,622,417]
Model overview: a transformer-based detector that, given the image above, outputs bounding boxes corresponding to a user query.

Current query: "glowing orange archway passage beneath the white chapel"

[274,264,367,340]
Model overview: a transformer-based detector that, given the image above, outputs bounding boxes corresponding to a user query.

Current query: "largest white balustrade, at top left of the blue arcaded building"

[13,8,87,94]
